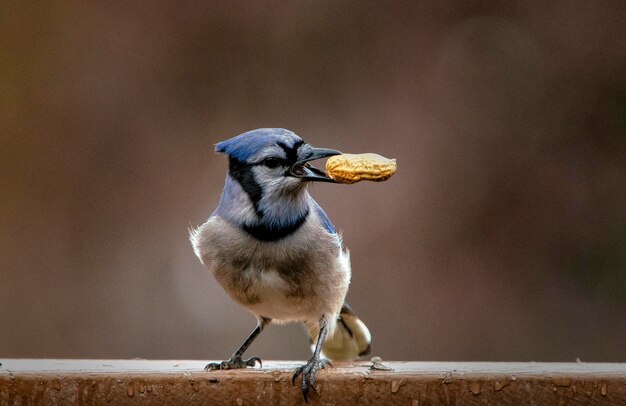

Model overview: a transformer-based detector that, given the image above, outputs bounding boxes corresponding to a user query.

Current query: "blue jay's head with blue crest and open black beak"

[215,128,341,204]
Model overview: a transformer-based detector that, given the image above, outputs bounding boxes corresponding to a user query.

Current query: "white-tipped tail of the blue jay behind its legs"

[307,302,372,361]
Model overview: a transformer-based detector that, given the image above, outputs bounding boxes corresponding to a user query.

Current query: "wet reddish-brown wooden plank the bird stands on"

[0,359,626,406]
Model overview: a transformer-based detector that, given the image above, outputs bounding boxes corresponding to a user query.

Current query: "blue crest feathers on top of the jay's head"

[215,128,302,162]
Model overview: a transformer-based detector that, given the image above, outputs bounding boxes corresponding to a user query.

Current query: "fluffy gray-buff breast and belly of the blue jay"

[192,214,350,321]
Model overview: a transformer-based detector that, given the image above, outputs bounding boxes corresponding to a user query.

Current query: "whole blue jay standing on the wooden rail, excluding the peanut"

[190,128,371,400]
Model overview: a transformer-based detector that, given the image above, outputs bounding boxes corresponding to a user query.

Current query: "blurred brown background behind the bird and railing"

[0,0,626,361]
